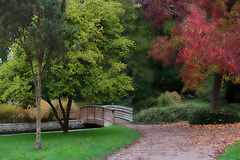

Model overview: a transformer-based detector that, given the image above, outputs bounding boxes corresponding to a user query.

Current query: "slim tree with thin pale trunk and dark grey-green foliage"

[0,0,69,149]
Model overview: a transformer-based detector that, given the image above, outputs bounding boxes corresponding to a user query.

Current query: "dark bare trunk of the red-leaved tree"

[210,74,222,109]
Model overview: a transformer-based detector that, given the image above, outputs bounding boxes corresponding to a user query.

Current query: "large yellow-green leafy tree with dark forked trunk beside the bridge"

[43,0,133,132]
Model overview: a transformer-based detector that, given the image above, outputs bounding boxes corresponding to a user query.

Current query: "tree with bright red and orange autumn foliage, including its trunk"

[139,0,240,108]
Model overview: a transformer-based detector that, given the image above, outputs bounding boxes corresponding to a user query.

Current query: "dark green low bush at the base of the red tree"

[188,108,240,124]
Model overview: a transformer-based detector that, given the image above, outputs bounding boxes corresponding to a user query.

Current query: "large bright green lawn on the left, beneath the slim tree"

[0,125,140,160]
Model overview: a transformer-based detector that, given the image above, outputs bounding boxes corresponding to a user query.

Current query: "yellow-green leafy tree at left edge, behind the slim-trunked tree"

[0,55,35,107]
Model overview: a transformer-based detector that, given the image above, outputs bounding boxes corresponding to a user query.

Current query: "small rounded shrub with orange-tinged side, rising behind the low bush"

[157,91,181,107]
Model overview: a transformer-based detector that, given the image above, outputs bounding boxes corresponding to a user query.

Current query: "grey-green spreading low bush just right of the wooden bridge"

[134,103,208,124]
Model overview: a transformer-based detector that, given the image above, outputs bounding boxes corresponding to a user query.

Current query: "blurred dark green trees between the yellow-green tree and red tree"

[115,0,182,110]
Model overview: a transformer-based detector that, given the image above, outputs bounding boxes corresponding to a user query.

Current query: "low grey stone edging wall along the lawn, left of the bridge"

[0,121,84,135]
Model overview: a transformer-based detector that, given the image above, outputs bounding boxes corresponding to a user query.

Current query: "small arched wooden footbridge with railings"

[59,105,133,126]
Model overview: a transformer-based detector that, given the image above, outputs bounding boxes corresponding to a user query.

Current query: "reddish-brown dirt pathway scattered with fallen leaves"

[108,121,240,160]
